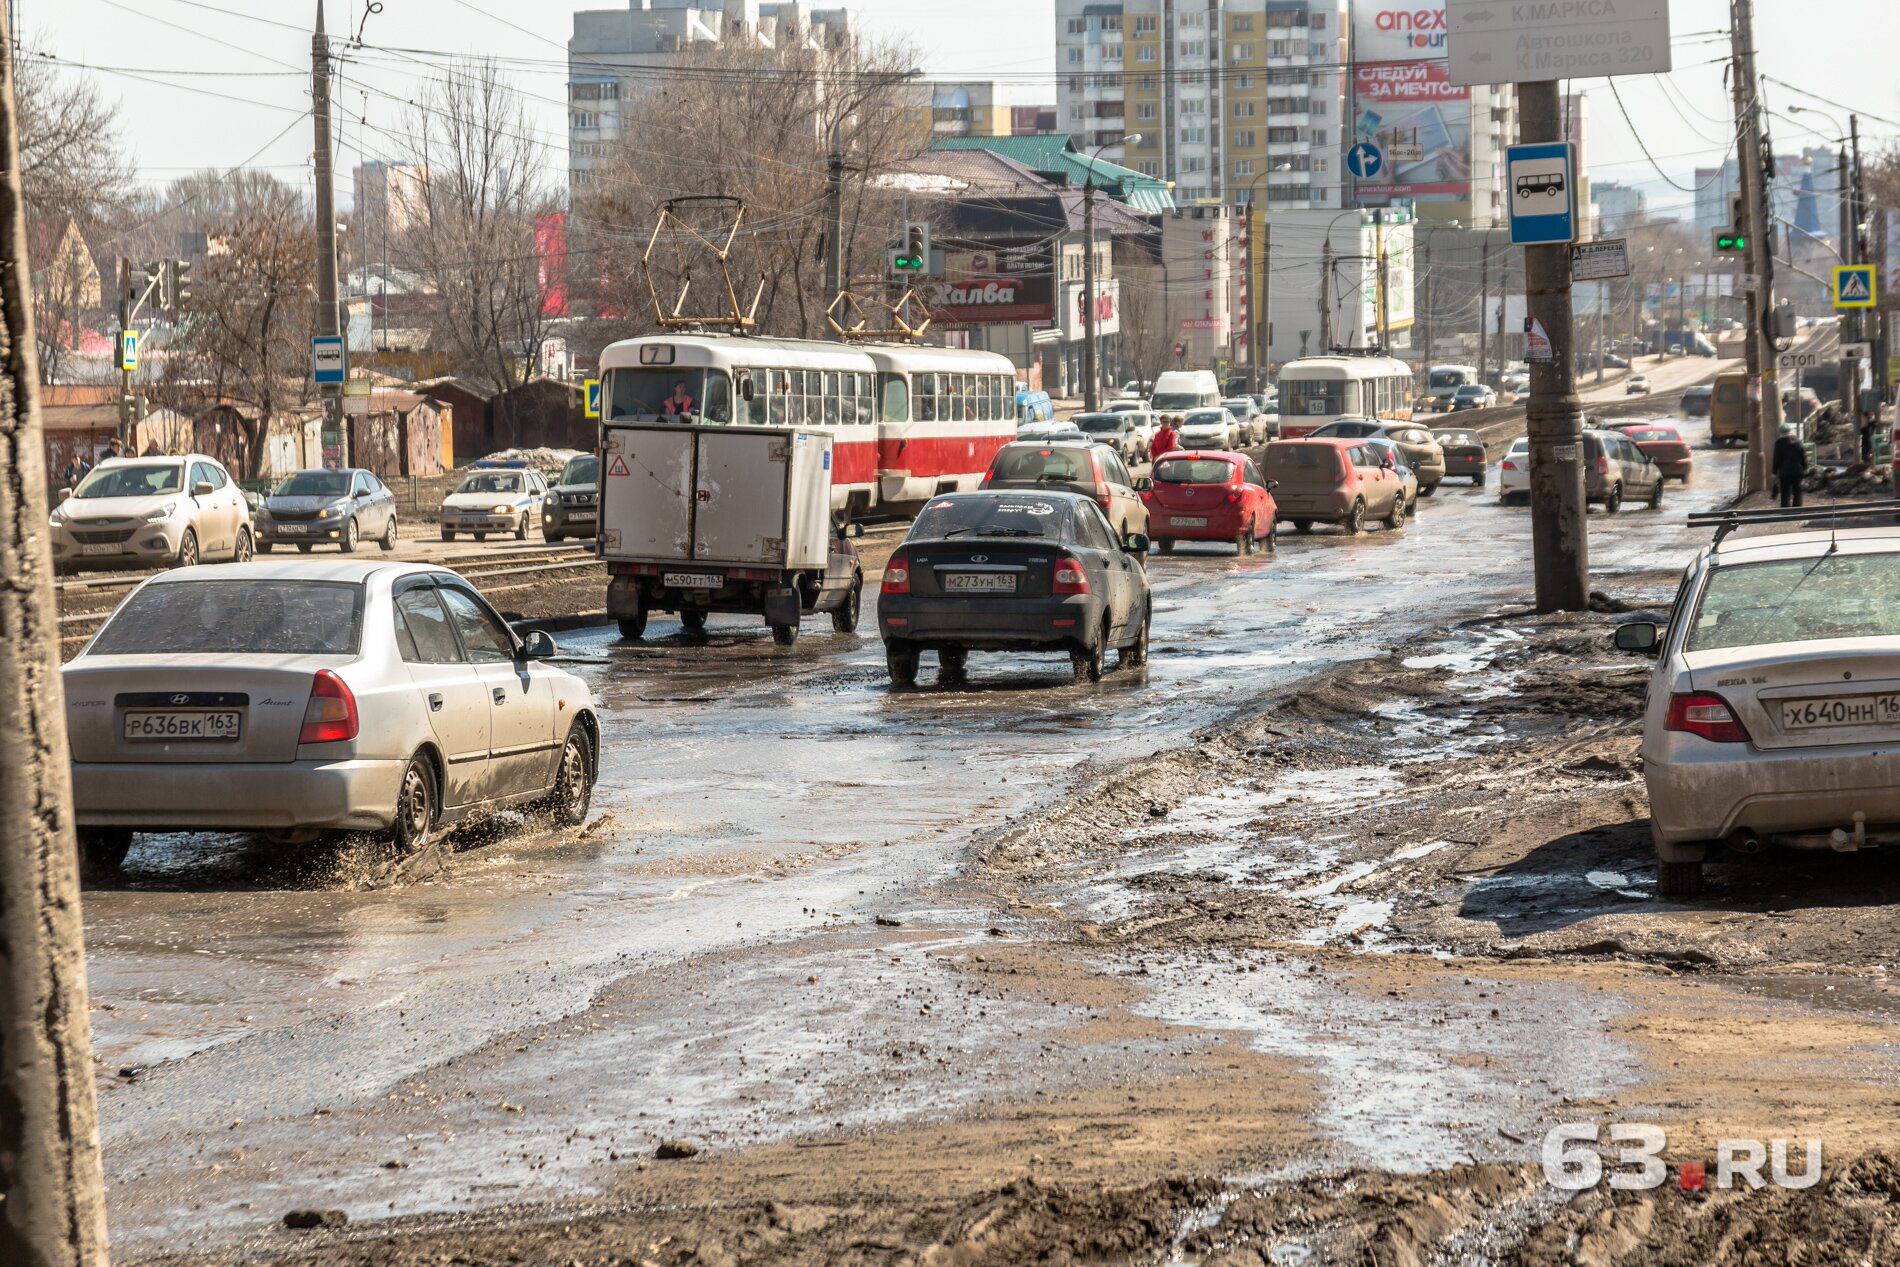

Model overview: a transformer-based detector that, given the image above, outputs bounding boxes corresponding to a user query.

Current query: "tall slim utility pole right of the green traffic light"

[1729,0,1780,492]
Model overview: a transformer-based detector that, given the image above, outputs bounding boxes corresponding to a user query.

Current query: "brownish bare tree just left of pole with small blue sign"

[160,171,317,477]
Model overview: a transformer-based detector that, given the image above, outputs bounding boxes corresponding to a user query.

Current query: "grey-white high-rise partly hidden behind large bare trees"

[568,0,855,186]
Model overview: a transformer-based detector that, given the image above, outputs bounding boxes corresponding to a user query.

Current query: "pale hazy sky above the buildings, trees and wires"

[15,0,1900,215]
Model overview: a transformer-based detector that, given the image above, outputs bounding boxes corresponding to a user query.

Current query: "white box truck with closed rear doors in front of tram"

[600,422,865,646]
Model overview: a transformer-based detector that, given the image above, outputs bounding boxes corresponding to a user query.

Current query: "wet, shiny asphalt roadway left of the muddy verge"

[86,421,1737,1252]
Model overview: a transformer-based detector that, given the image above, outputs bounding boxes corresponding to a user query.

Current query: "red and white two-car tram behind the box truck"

[600,334,1017,515]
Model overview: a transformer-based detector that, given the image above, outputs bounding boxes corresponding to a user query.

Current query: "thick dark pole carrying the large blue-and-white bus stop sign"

[1518,80,1590,612]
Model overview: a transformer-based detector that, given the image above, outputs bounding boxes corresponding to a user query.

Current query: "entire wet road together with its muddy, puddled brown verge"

[100,412,1900,1267]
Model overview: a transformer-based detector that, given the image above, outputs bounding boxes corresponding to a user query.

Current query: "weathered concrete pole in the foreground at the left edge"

[0,8,106,1267]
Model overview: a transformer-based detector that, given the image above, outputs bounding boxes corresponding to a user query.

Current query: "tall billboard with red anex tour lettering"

[1353,0,1471,201]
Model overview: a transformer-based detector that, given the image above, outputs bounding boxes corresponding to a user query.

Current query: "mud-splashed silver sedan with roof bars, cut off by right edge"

[1617,511,1900,897]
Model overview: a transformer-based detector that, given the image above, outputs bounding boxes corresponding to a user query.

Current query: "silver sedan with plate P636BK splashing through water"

[61,560,600,872]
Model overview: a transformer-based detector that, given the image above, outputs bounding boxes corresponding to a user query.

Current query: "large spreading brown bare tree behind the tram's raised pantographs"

[576,40,931,336]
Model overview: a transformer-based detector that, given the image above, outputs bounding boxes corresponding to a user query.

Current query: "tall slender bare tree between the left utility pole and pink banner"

[397,61,557,441]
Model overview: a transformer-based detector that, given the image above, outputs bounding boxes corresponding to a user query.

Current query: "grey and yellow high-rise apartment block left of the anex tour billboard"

[1056,0,1347,209]
